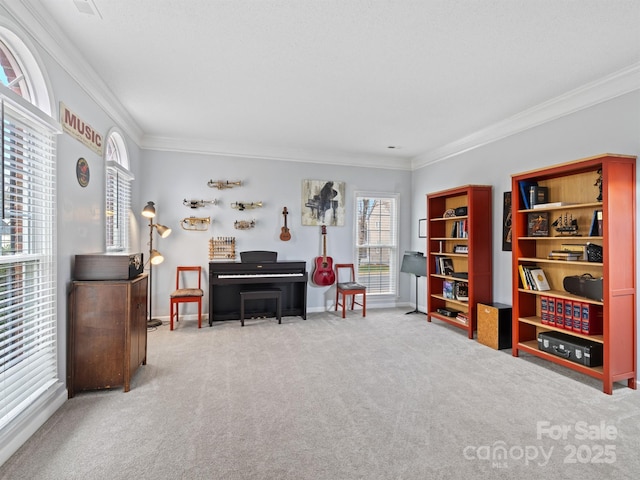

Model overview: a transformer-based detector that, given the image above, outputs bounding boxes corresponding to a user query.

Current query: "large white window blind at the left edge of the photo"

[0,89,59,429]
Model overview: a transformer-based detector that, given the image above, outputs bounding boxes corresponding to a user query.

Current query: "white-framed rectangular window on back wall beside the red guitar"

[353,191,400,296]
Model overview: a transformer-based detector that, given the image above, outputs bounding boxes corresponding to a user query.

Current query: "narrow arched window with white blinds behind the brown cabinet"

[105,131,133,252]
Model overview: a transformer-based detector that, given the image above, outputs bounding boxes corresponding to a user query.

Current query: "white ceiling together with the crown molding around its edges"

[13,0,640,168]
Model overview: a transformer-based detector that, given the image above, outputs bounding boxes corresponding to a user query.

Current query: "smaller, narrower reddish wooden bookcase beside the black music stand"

[427,185,493,338]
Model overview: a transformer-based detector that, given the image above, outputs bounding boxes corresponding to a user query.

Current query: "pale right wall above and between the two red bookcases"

[412,90,640,364]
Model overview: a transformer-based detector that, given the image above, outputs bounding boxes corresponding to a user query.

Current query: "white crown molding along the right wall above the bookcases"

[411,63,640,170]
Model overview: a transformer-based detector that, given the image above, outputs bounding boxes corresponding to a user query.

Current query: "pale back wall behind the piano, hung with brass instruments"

[139,151,412,318]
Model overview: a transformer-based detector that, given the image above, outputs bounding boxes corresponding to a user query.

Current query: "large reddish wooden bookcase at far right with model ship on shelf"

[512,154,636,394]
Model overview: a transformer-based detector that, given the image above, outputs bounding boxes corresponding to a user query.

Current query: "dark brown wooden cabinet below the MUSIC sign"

[67,274,147,398]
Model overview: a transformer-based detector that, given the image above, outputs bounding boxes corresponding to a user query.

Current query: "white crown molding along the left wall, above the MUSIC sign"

[4,0,144,145]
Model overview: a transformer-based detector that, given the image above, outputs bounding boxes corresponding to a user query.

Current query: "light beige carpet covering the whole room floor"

[0,309,640,480]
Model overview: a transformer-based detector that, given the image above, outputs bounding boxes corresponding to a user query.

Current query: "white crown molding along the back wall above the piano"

[140,136,411,171]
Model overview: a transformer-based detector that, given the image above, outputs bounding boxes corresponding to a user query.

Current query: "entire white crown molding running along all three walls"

[3,0,640,170]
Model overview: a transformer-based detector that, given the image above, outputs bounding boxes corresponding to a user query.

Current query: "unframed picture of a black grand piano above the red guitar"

[301,180,344,227]
